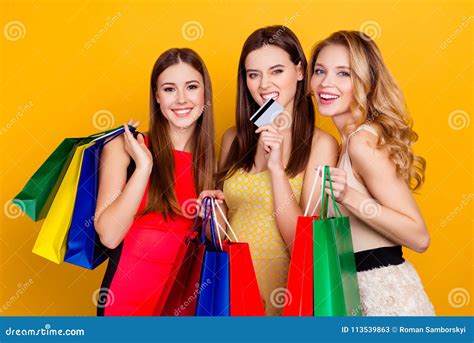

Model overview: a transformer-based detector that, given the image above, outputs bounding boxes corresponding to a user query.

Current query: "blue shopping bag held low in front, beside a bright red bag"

[196,198,230,316]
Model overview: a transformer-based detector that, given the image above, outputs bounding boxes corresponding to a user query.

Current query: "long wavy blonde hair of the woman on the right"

[308,31,426,191]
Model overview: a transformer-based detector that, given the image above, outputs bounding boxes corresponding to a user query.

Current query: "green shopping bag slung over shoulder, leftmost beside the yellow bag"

[13,126,126,221]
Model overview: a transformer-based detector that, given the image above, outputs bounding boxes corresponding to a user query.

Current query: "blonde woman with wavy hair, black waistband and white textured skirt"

[309,31,434,316]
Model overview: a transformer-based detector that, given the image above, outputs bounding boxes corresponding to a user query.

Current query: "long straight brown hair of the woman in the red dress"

[140,48,216,218]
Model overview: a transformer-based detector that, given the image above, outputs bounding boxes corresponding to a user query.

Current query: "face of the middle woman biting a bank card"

[245,45,303,113]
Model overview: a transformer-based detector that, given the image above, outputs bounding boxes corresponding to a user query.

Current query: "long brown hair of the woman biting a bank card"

[217,26,314,185]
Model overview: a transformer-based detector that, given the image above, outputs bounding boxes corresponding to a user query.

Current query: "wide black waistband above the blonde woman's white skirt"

[354,245,405,272]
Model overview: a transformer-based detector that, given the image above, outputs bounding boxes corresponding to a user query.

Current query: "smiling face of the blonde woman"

[311,44,353,117]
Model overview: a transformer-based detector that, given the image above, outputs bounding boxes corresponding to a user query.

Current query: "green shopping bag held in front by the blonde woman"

[313,166,362,316]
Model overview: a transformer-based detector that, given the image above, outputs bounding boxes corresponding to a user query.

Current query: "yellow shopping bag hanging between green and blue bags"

[33,142,94,264]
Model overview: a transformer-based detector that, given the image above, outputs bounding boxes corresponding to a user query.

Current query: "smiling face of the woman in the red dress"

[156,62,205,128]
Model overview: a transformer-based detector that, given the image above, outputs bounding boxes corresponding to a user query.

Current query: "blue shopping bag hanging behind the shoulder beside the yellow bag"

[64,126,135,269]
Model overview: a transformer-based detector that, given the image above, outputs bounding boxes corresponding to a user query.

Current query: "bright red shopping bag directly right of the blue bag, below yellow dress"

[223,241,265,316]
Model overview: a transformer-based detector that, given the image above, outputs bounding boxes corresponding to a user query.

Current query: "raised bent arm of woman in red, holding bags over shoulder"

[94,127,152,249]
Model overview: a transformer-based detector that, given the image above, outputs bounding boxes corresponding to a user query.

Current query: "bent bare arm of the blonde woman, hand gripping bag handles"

[326,131,430,252]
